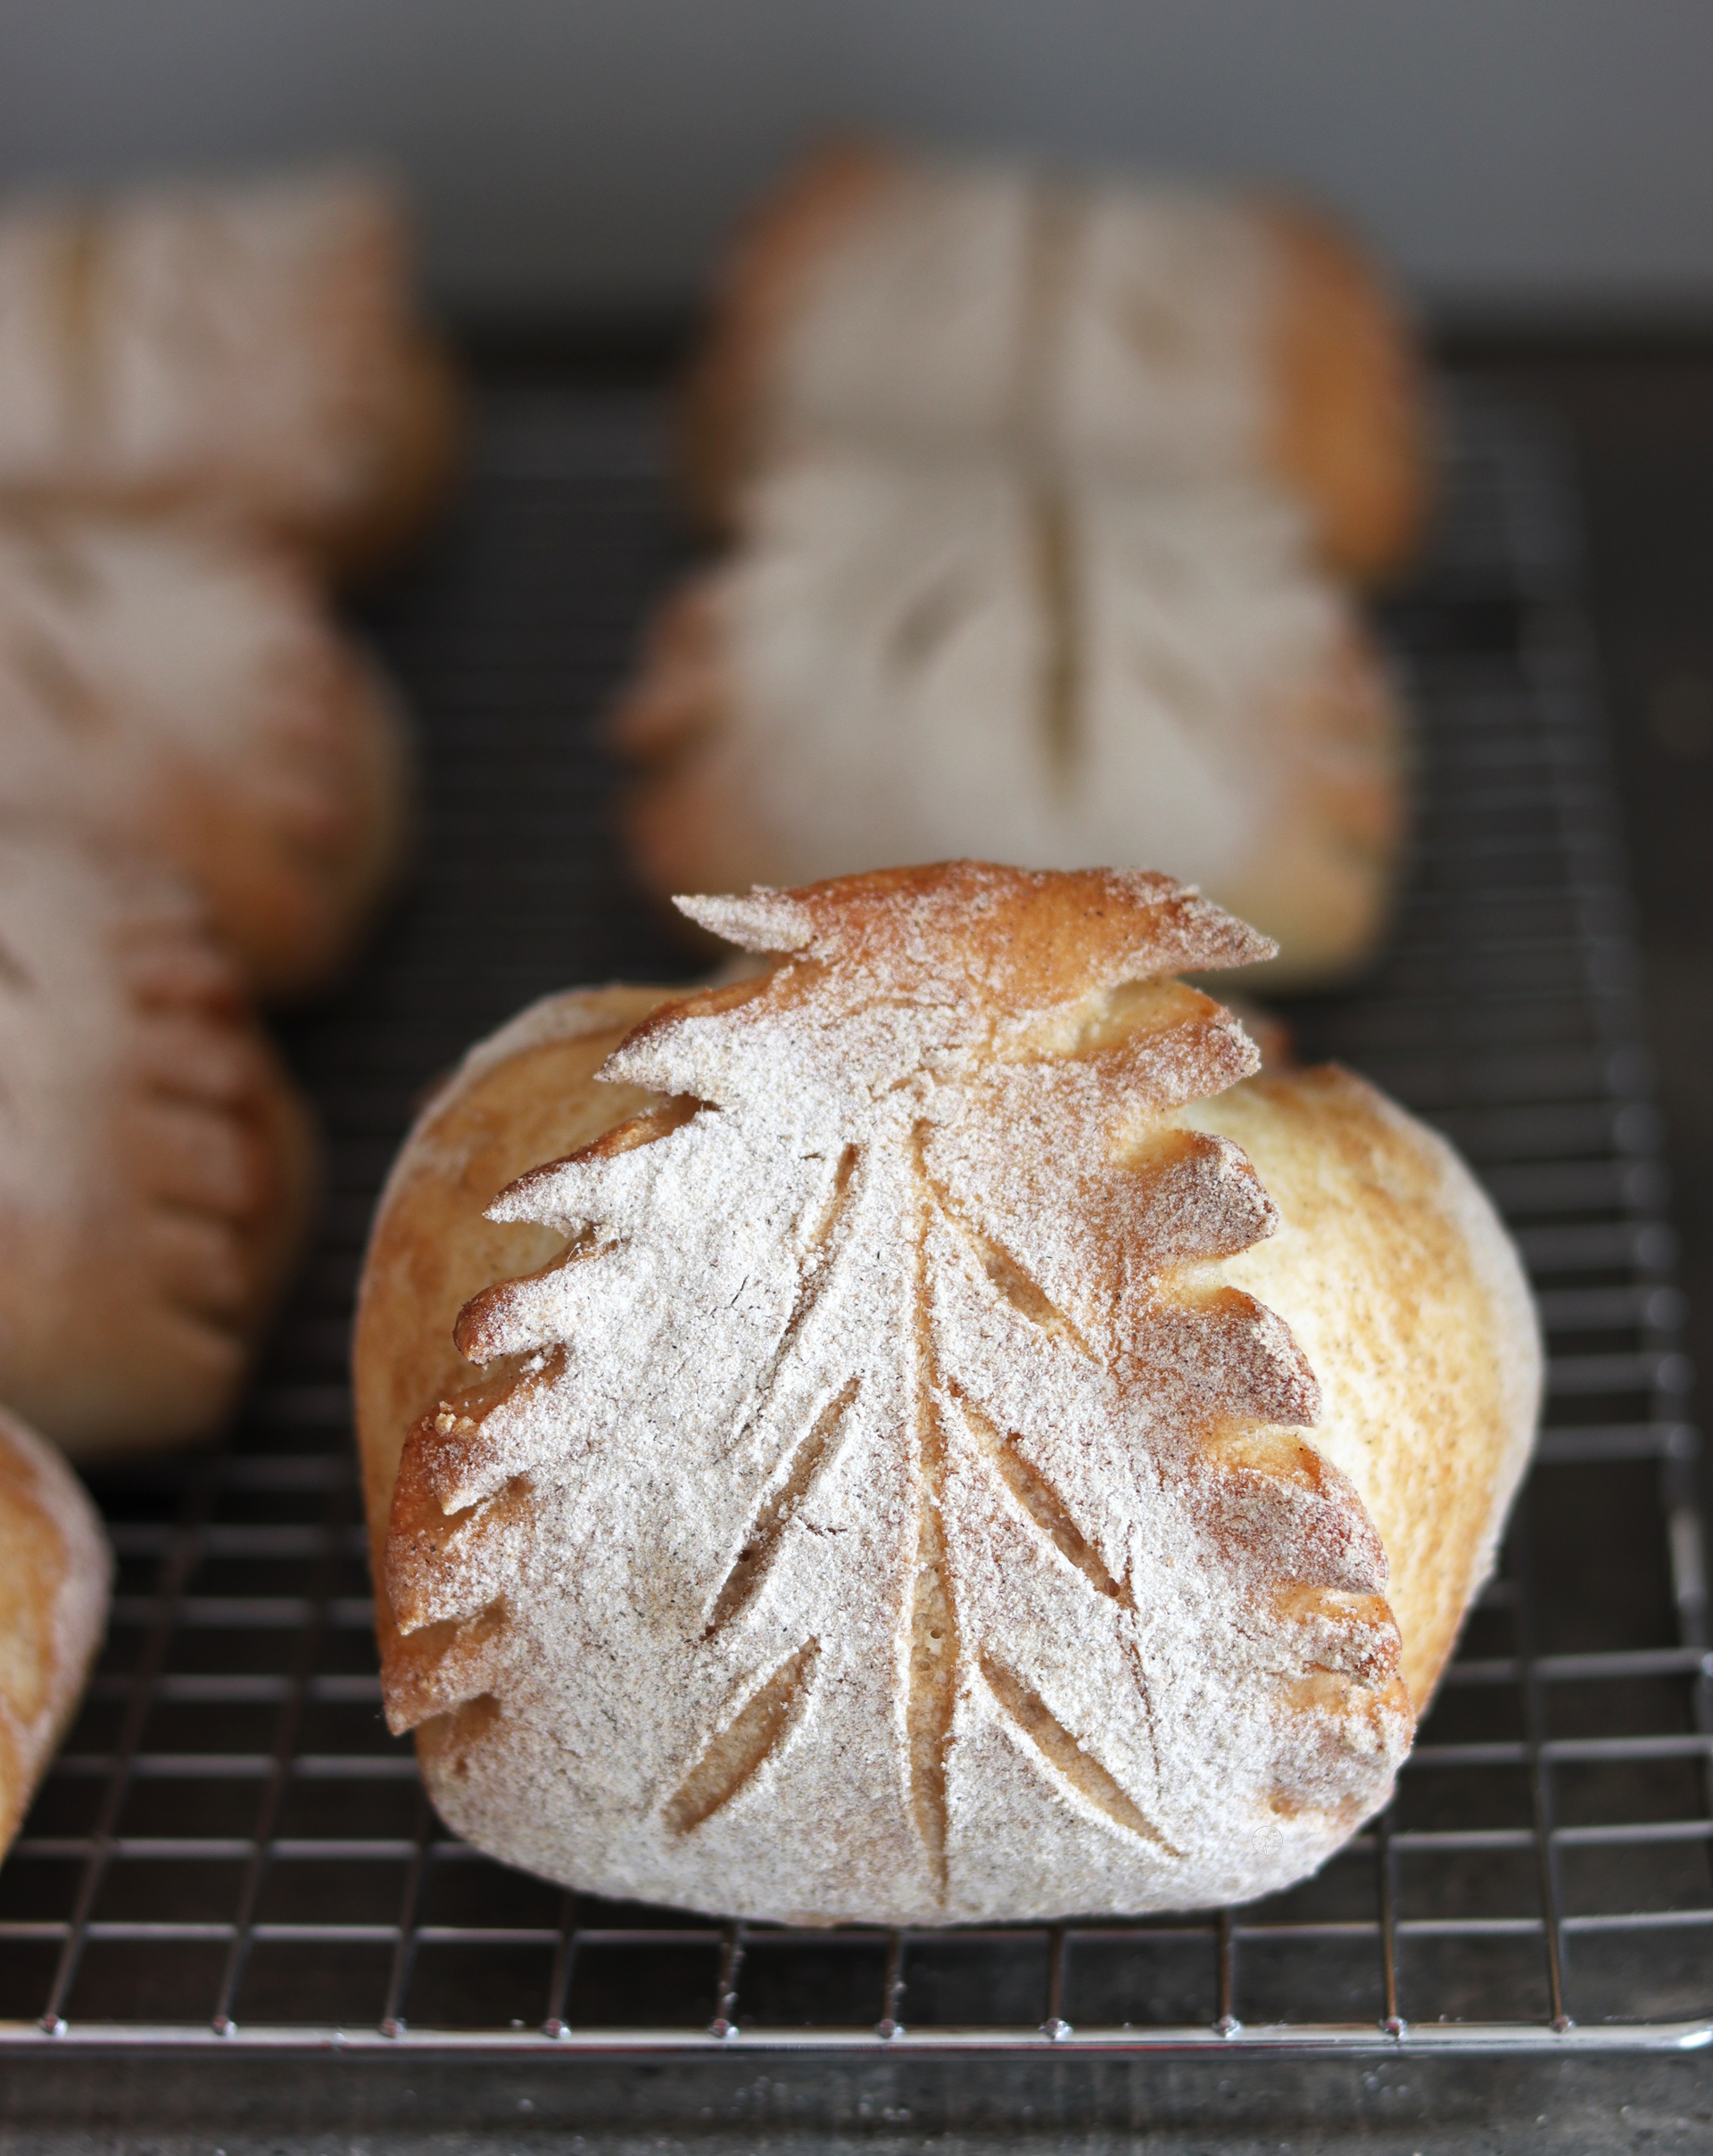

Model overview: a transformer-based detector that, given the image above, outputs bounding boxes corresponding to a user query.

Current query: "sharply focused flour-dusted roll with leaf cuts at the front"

[356,863,1541,1923]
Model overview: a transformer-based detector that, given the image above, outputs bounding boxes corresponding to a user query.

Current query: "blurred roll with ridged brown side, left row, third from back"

[0,823,313,1459]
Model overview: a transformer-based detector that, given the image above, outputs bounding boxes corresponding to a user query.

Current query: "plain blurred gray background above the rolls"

[0,0,1713,315]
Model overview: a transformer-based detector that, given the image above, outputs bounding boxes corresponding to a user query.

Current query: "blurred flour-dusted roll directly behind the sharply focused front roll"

[615,453,1404,987]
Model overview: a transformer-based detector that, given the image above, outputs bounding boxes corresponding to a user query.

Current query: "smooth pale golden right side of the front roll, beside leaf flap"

[1188,1065,1541,1714]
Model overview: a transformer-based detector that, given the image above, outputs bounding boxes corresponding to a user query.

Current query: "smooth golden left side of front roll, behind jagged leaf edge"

[354,987,666,1649]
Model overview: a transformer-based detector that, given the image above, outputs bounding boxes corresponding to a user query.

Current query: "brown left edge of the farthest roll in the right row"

[677,140,898,531]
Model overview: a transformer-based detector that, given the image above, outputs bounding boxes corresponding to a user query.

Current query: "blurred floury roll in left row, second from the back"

[0,513,408,996]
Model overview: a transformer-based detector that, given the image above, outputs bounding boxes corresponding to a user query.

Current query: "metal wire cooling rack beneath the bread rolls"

[0,388,1713,2051]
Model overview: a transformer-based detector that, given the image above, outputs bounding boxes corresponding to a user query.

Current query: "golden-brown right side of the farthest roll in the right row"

[1260,202,1430,582]
